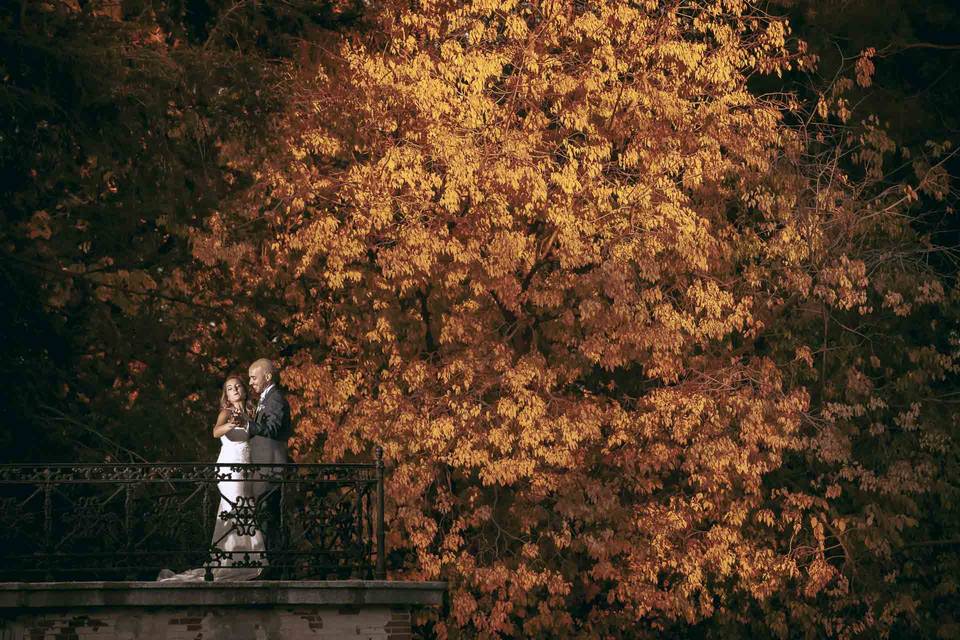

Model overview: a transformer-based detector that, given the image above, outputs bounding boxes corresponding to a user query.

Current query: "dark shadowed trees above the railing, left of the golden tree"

[0,0,355,461]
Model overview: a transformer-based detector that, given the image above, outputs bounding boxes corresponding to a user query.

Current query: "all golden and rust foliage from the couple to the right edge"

[3,0,960,638]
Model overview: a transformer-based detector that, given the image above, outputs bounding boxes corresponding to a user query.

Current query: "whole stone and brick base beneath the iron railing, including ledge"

[0,581,446,640]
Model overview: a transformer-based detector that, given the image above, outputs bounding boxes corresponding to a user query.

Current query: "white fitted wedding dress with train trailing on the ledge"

[157,429,266,582]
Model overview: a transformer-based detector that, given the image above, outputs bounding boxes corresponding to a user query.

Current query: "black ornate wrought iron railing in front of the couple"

[0,449,385,581]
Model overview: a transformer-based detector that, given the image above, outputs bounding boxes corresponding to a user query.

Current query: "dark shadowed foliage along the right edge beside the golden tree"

[775,0,960,637]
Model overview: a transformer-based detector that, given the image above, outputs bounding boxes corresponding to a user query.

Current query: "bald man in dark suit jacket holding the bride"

[243,358,293,575]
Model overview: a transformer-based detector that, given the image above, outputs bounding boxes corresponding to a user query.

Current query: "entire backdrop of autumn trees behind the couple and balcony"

[0,0,960,638]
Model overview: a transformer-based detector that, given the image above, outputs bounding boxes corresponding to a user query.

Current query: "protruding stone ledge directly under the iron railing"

[0,580,447,609]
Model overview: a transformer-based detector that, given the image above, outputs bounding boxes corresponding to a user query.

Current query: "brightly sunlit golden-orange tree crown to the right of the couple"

[198,0,952,637]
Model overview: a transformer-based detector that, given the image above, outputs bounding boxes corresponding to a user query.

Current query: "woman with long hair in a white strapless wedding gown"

[157,376,266,582]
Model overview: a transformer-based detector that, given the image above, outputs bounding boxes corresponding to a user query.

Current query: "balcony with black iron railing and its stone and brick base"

[0,456,446,640]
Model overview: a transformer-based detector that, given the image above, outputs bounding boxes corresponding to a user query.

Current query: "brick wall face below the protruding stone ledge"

[0,605,411,640]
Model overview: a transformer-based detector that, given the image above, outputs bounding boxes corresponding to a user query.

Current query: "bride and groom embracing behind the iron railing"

[158,359,293,582]
